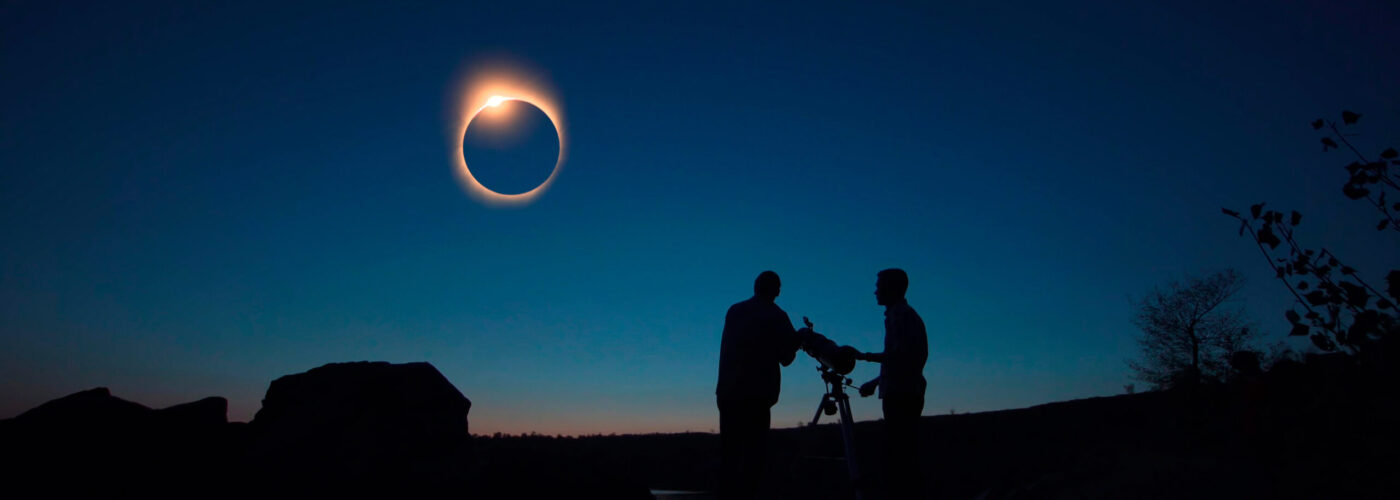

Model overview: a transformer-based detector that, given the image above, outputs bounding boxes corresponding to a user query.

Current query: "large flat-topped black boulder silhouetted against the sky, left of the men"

[249,361,472,480]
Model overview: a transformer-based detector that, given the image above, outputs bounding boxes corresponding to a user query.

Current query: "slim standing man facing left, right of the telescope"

[857,269,928,499]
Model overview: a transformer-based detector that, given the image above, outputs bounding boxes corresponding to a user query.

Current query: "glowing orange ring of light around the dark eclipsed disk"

[451,64,566,206]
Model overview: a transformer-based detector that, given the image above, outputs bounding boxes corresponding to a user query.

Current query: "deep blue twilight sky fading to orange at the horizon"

[0,1,1400,434]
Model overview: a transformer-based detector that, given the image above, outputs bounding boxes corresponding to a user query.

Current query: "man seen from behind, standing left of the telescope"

[714,270,798,499]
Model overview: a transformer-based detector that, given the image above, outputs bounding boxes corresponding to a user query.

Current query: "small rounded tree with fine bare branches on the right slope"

[1128,269,1253,388]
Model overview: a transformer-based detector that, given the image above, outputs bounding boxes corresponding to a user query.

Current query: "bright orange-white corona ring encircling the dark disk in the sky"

[454,78,564,206]
